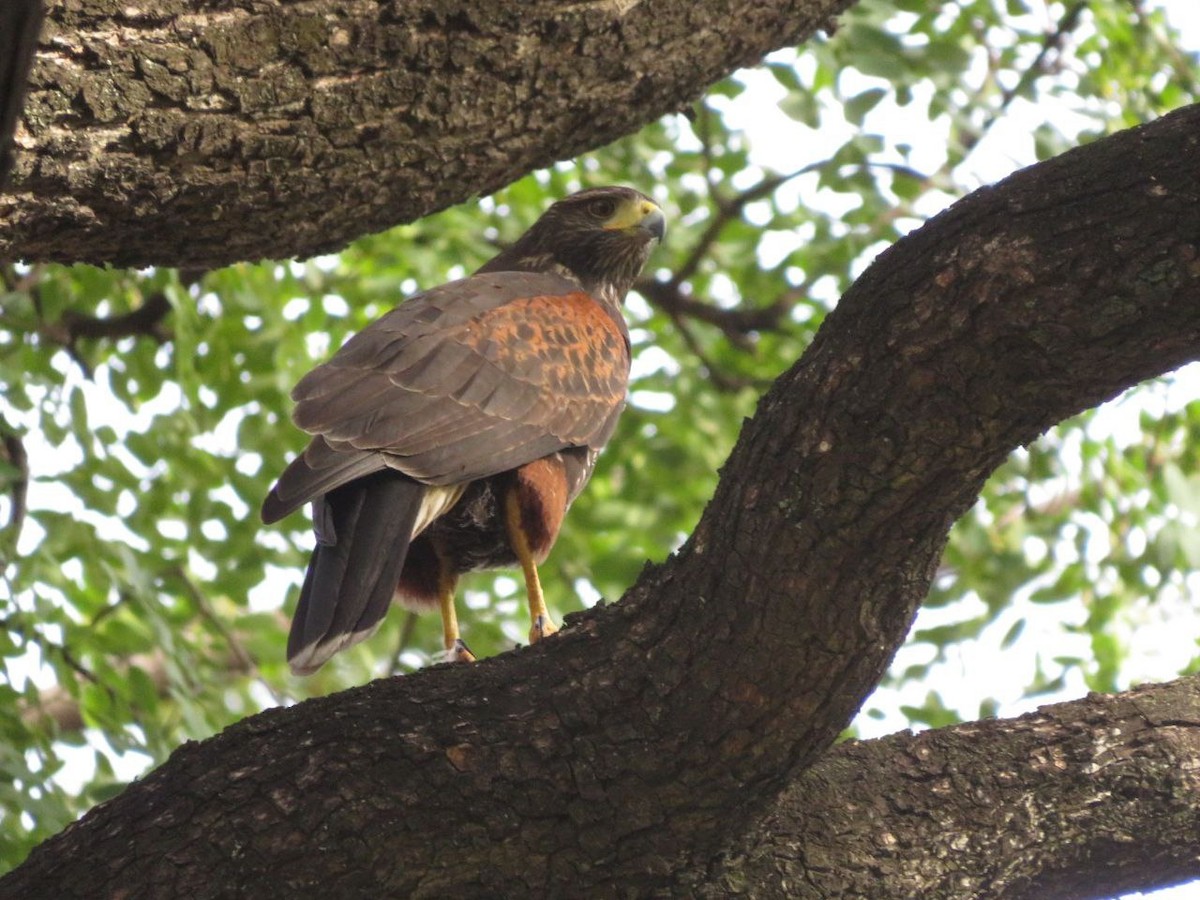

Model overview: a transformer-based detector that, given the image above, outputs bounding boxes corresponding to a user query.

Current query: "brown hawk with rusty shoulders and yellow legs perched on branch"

[263,187,665,674]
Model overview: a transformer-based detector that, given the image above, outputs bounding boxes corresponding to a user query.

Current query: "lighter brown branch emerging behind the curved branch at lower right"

[707,678,1200,900]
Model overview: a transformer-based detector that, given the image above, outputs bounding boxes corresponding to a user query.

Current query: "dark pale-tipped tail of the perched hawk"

[288,472,425,674]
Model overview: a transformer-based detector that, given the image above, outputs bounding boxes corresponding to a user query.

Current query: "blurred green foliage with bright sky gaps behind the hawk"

[0,0,1200,869]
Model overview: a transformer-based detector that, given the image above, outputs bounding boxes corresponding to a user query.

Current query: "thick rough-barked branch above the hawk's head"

[0,0,851,268]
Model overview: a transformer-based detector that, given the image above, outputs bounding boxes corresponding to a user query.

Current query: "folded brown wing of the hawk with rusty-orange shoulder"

[263,272,630,521]
